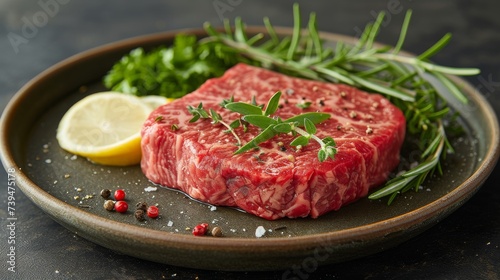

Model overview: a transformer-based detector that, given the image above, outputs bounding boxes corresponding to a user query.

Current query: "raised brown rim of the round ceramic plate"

[0,26,500,270]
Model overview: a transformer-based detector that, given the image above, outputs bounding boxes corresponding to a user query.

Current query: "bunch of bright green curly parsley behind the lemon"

[104,34,236,98]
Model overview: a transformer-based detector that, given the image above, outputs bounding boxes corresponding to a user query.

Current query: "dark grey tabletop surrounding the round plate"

[0,0,500,279]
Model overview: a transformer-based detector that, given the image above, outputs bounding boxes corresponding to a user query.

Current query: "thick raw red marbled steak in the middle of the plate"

[141,64,406,220]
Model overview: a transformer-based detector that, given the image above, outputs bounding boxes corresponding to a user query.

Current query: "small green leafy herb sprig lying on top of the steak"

[188,91,337,162]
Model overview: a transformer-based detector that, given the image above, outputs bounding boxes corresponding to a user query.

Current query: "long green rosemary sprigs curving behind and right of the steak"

[202,4,479,204]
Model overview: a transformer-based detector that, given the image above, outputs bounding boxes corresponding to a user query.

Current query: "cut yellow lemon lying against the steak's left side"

[57,92,168,166]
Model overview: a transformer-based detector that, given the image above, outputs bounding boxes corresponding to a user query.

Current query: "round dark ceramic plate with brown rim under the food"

[1,28,499,270]
